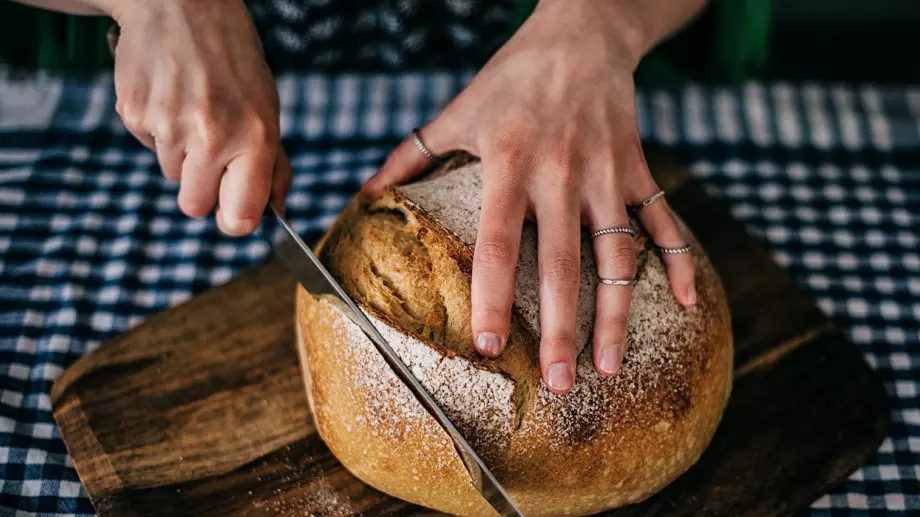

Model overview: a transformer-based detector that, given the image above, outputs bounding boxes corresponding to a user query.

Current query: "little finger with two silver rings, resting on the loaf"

[637,192,697,306]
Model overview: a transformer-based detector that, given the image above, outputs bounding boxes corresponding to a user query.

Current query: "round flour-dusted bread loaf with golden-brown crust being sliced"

[295,155,732,516]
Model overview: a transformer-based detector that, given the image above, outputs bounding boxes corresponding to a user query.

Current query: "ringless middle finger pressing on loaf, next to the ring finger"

[534,188,581,393]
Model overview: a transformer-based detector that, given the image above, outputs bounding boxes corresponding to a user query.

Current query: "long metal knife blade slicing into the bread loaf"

[263,206,524,517]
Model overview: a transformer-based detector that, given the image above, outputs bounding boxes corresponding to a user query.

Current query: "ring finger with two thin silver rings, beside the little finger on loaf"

[588,194,636,375]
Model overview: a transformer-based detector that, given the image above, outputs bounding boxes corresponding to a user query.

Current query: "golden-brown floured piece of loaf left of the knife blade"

[296,287,490,515]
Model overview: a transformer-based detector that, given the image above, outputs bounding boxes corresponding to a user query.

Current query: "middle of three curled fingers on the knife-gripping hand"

[178,146,224,217]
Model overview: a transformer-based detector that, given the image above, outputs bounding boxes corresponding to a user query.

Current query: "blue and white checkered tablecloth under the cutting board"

[0,73,920,516]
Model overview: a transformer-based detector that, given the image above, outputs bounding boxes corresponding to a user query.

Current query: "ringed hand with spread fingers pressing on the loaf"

[363,0,696,393]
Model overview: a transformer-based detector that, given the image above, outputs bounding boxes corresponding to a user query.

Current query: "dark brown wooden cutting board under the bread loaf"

[51,147,887,517]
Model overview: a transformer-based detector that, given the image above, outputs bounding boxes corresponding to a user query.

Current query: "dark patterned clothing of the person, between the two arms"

[247,0,516,70]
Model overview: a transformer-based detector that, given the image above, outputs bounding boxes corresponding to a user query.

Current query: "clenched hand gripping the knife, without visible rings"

[101,0,291,235]
